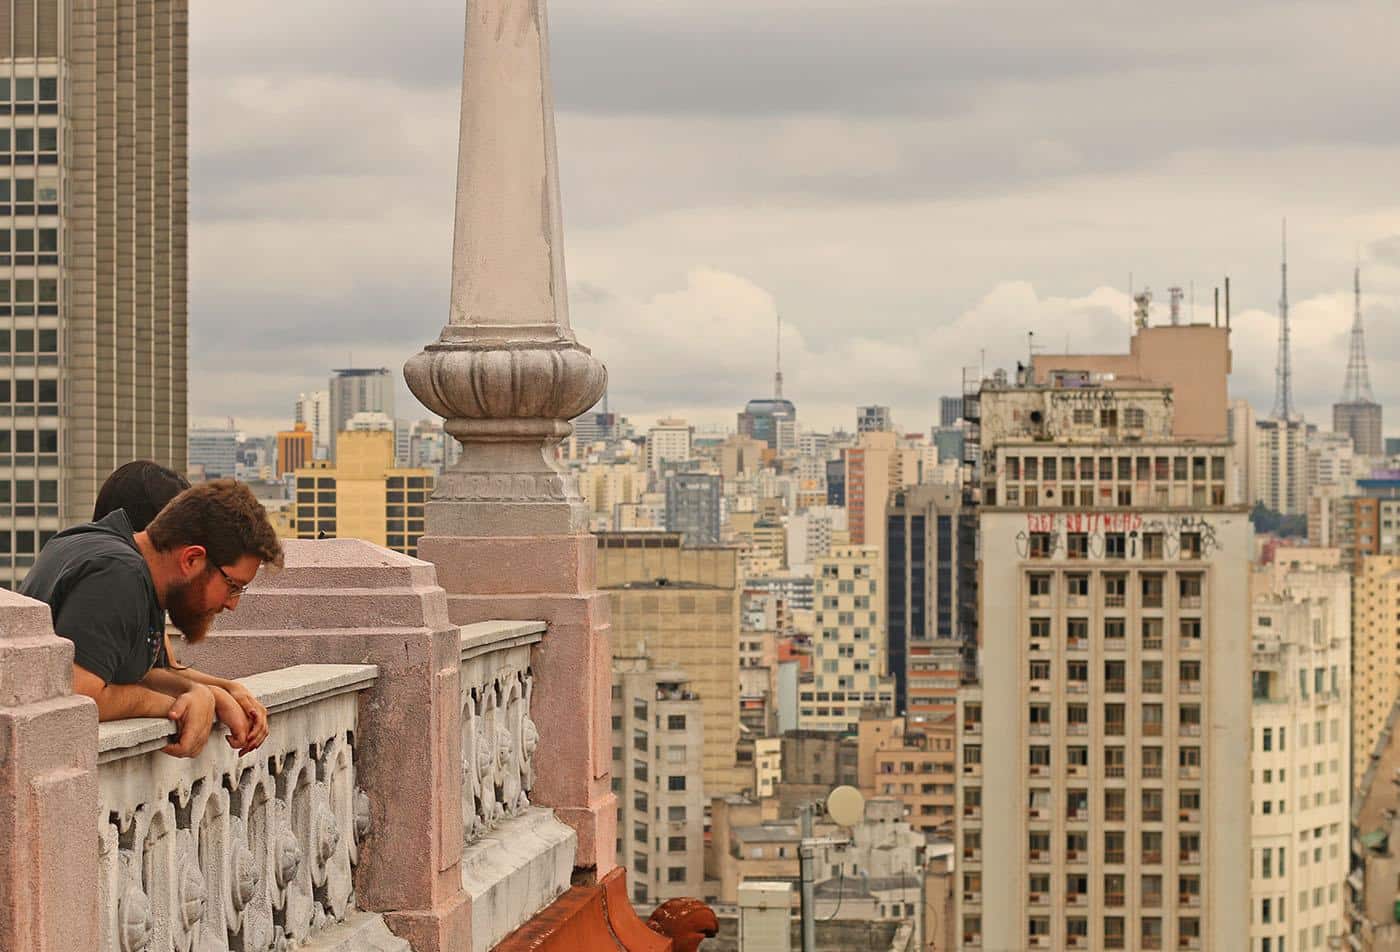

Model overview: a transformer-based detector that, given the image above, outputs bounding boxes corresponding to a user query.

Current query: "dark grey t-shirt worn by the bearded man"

[20,510,167,685]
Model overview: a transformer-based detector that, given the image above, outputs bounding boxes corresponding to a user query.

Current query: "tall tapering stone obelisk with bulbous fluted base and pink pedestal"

[403,0,616,875]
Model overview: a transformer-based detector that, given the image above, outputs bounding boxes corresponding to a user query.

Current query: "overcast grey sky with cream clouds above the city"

[190,0,1400,433]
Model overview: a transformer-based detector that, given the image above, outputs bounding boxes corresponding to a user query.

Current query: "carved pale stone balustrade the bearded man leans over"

[97,665,385,952]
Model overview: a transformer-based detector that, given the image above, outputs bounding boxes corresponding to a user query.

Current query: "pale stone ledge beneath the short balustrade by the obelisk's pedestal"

[462,806,578,952]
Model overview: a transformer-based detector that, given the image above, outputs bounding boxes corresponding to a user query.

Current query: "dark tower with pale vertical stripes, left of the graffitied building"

[885,484,977,722]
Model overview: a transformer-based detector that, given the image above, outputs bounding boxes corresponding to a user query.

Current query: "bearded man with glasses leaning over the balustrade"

[20,480,281,757]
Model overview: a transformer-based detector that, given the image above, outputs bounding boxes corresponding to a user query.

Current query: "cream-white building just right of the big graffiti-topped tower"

[1249,550,1351,949]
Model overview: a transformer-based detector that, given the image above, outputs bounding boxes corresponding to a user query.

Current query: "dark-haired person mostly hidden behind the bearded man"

[92,459,267,755]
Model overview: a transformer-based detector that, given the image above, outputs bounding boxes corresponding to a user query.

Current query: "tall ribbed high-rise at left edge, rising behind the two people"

[0,0,189,585]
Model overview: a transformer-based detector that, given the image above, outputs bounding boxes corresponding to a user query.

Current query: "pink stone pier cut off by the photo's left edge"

[0,589,101,952]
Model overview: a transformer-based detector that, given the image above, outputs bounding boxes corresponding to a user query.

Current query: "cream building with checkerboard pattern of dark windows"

[798,546,895,734]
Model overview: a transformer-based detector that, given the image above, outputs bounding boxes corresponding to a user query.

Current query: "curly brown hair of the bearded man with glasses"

[146,479,281,567]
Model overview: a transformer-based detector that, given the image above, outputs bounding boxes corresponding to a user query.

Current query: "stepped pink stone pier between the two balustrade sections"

[183,539,472,952]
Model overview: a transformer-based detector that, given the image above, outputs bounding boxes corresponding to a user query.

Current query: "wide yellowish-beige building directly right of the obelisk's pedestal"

[598,532,752,797]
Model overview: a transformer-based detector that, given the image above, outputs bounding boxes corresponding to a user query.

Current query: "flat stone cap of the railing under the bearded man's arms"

[97,665,379,762]
